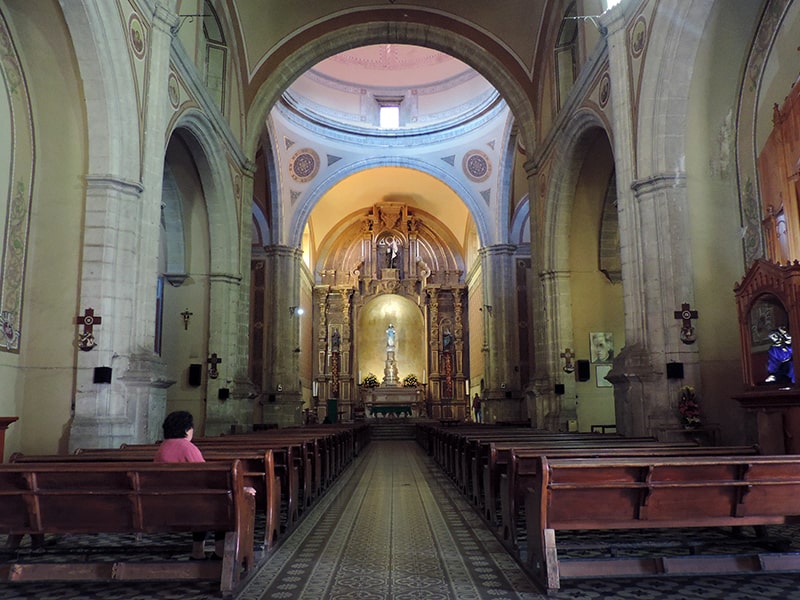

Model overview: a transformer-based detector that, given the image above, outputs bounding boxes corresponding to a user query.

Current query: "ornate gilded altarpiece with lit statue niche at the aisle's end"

[313,202,468,419]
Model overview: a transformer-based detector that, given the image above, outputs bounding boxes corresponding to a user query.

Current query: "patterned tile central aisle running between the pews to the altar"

[237,441,542,600]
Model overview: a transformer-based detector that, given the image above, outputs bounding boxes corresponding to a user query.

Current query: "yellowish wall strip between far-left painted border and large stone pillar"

[0,1,86,455]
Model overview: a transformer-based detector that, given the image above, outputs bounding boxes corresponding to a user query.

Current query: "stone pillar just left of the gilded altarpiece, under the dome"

[261,246,303,427]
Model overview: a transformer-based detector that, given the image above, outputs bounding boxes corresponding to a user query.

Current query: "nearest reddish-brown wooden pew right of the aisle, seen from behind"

[525,455,800,591]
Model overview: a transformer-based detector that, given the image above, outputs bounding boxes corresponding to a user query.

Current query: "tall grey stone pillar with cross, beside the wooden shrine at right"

[602,10,696,436]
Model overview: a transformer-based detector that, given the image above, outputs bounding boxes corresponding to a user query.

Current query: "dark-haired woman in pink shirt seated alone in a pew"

[153,410,225,560]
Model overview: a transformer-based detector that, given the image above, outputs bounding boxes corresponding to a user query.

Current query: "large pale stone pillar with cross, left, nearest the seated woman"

[69,5,178,450]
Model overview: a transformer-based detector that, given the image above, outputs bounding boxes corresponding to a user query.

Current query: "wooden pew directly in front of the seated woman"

[9,444,281,551]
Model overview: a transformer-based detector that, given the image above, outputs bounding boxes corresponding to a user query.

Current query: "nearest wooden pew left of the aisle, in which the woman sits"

[0,461,255,595]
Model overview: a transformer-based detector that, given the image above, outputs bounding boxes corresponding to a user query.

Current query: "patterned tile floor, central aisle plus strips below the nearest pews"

[0,441,800,600]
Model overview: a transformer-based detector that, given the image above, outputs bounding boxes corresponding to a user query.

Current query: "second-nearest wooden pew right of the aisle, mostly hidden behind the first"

[500,443,759,553]
